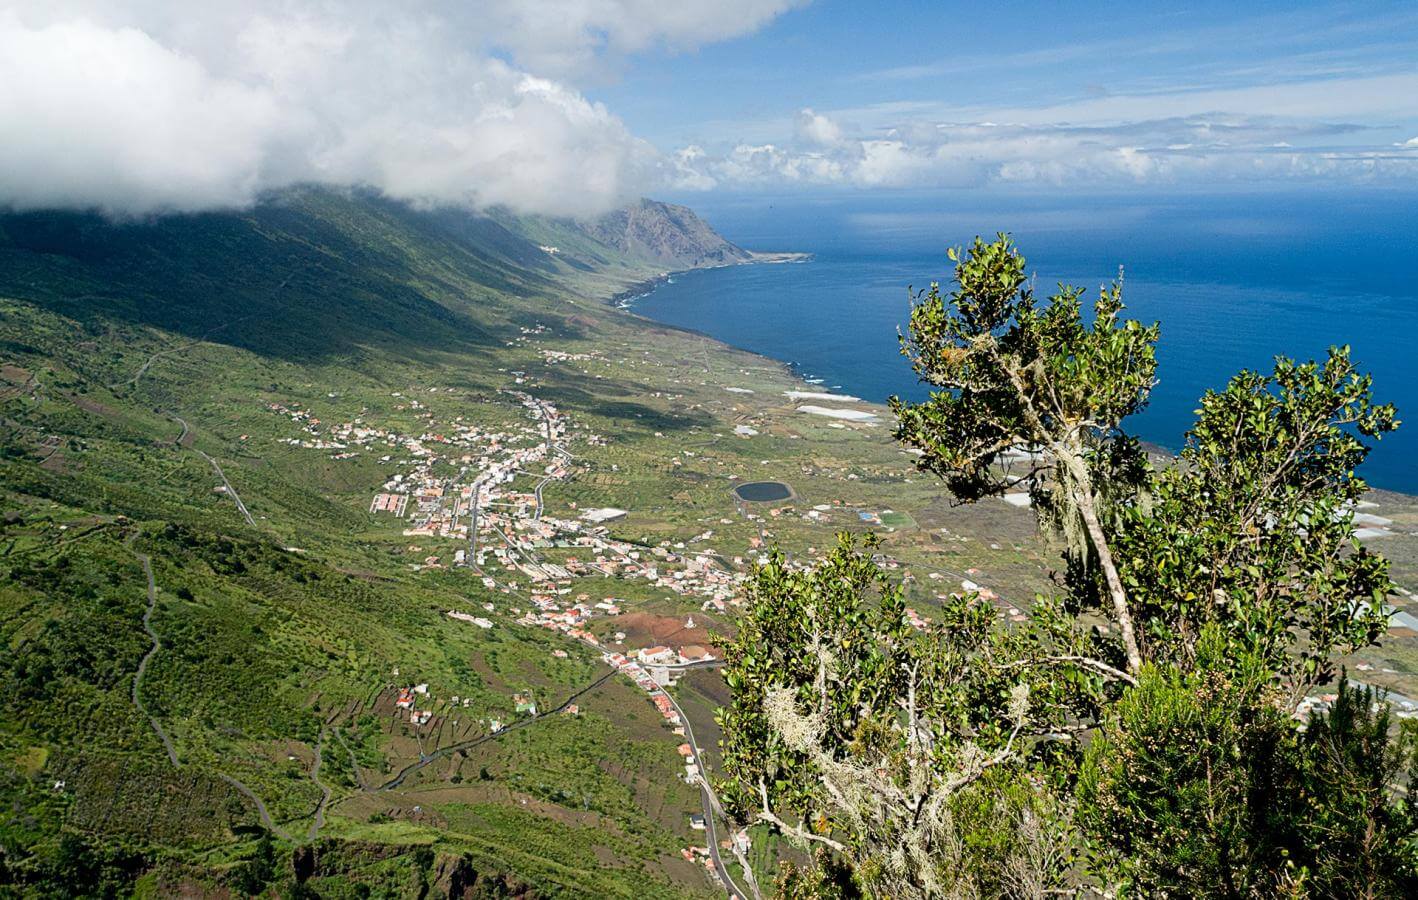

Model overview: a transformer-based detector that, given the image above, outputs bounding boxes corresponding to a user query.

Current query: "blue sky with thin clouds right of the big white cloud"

[586,0,1418,197]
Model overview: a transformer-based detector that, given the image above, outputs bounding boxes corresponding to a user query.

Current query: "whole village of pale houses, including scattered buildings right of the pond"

[268,374,1208,882]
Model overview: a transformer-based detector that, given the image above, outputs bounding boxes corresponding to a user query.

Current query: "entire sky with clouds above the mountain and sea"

[0,0,1418,215]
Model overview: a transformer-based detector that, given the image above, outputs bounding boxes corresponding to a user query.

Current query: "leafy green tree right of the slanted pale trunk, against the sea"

[1113,347,1398,706]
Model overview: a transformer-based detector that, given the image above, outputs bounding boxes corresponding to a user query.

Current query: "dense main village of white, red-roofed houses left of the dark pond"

[268,379,746,879]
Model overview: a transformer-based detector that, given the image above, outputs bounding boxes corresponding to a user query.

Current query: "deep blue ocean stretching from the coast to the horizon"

[634,190,1418,493]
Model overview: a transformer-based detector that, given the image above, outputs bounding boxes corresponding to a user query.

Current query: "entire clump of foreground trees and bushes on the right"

[720,235,1418,897]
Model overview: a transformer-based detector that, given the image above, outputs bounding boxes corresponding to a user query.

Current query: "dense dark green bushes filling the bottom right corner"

[1079,657,1418,897]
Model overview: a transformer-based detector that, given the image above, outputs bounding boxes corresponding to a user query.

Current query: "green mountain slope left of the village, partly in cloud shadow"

[0,190,754,896]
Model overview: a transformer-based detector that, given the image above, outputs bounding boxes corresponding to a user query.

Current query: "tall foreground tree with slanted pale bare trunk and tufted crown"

[891,234,1159,675]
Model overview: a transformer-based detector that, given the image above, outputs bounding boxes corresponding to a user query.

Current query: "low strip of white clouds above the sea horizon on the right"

[681,94,1418,189]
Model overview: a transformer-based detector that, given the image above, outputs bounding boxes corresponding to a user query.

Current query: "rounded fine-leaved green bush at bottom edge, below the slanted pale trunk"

[1078,628,1296,897]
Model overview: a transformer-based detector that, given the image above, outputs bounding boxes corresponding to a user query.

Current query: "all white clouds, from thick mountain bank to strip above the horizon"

[0,0,1418,215]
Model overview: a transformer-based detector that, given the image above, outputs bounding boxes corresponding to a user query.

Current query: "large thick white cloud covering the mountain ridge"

[0,0,794,214]
